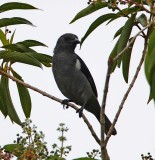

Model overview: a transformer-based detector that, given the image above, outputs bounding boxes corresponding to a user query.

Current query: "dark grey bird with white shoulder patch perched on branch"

[52,33,117,135]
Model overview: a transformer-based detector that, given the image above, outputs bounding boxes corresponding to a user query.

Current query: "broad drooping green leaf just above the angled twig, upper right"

[117,14,136,58]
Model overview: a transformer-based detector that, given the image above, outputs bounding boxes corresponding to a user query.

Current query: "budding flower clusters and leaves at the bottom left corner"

[0,119,71,160]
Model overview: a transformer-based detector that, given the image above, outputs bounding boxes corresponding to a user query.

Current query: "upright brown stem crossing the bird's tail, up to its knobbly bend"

[100,58,112,160]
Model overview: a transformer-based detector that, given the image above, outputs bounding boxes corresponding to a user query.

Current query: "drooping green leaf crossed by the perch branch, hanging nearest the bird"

[11,69,32,118]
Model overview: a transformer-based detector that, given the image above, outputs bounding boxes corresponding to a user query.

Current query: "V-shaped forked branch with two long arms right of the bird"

[100,22,153,160]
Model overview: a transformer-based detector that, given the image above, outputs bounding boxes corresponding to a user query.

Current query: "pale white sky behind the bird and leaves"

[0,0,155,160]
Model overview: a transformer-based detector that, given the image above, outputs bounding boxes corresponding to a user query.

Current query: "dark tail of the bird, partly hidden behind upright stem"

[85,99,117,135]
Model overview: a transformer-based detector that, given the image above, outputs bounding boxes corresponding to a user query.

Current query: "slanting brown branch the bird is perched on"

[0,69,100,145]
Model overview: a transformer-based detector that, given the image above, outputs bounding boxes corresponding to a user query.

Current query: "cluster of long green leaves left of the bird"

[0,2,52,125]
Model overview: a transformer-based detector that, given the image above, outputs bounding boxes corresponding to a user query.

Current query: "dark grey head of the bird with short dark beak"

[54,33,80,53]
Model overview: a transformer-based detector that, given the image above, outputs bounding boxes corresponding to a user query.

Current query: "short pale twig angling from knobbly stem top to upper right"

[113,21,153,62]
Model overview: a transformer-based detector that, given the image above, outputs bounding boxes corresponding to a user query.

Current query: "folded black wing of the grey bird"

[77,55,98,97]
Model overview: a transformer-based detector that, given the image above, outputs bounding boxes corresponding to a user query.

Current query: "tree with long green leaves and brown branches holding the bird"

[0,0,155,159]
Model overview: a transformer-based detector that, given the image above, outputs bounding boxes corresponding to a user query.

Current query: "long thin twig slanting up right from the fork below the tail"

[104,31,148,146]
